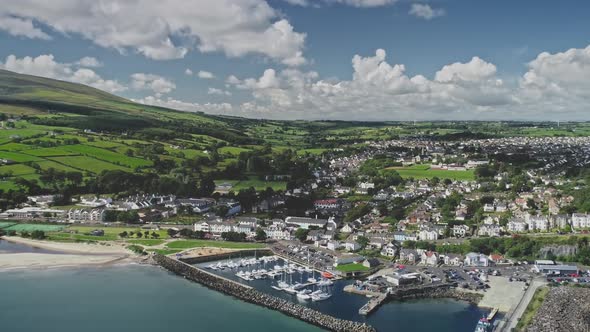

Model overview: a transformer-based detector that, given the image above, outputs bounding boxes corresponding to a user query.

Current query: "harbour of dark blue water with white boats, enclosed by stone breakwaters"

[187,253,488,331]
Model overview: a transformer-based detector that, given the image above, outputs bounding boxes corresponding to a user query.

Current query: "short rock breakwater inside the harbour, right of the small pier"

[389,284,483,304]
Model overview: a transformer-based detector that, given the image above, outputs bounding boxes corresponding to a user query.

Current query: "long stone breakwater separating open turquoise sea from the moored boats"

[154,255,376,332]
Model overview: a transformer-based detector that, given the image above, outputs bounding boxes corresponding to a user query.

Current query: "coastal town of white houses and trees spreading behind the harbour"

[0,137,590,331]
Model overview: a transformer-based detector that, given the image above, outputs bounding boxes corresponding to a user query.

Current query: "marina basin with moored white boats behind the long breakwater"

[196,257,487,332]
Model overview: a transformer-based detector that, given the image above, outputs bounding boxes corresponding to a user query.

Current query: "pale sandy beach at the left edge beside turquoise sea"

[0,237,134,270]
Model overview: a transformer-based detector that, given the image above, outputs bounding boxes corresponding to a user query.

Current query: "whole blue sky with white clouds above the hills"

[0,0,590,120]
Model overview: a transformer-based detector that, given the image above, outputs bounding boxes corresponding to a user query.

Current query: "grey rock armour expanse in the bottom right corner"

[526,286,590,332]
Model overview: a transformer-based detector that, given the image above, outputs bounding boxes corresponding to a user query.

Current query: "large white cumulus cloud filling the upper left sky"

[0,0,305,65]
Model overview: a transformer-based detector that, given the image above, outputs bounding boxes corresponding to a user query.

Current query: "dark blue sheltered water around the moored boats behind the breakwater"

[195,259,484,332]
